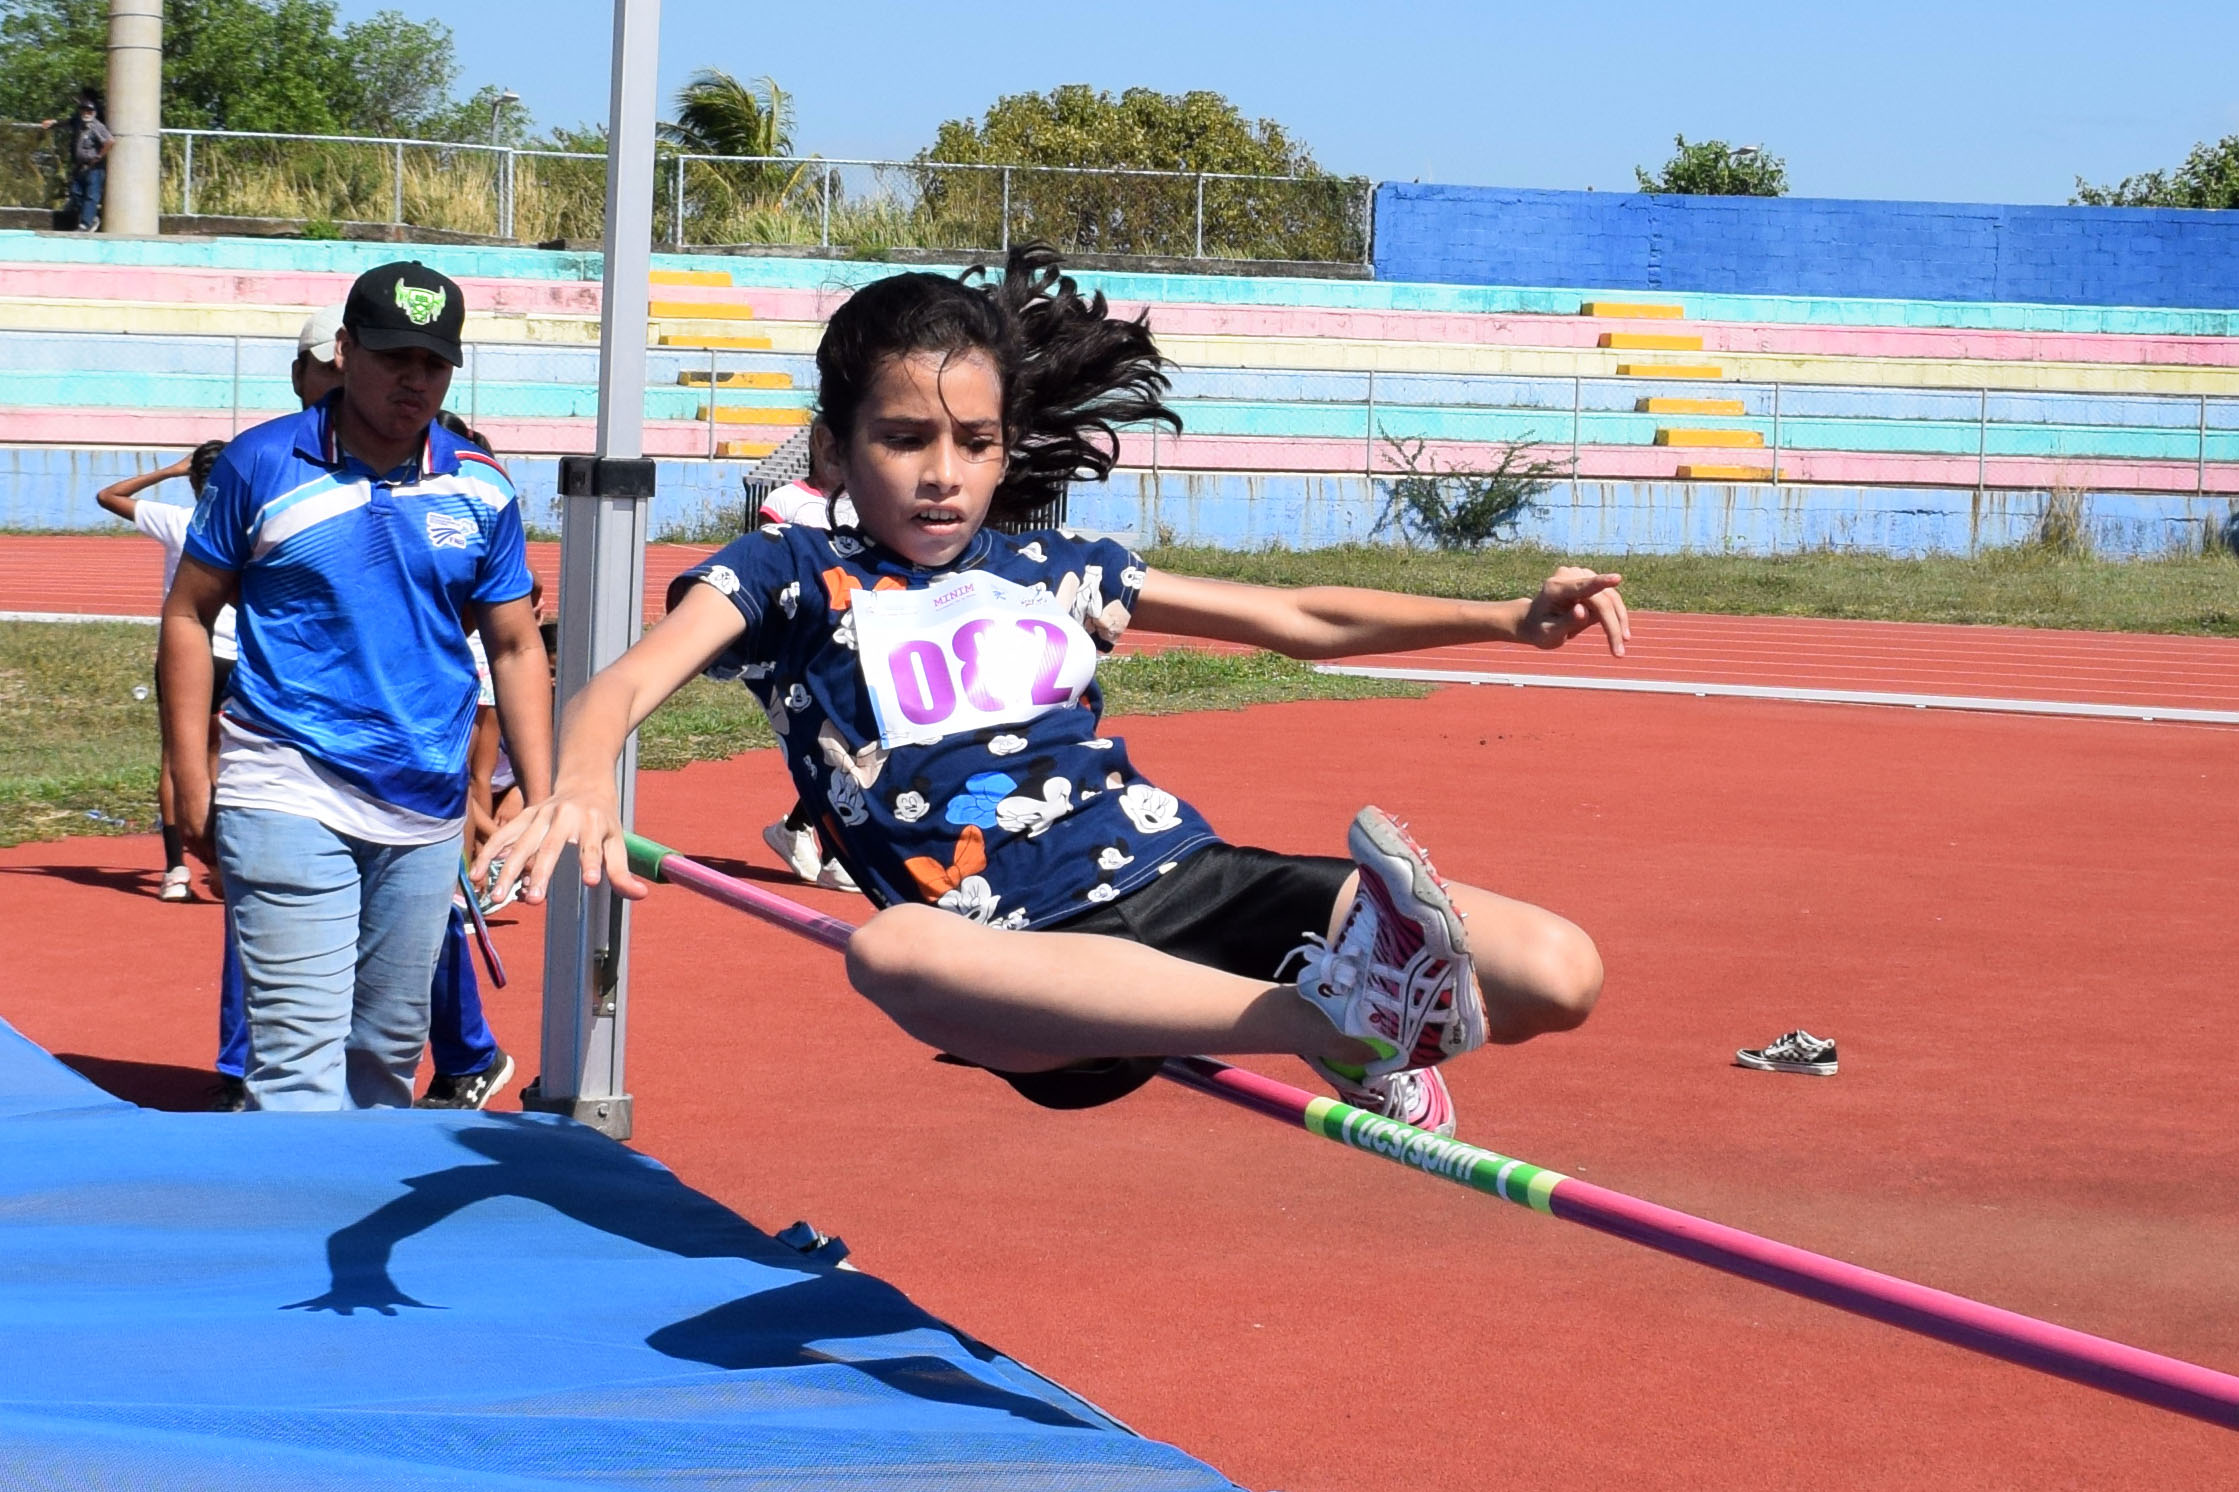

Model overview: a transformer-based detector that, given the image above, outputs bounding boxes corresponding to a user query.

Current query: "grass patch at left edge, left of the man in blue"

[0,623,163,845]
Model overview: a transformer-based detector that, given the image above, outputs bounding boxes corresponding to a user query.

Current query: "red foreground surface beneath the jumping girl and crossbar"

[0,690,2239,1492]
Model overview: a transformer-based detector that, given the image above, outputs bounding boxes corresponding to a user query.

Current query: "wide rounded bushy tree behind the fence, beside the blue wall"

[916,83,1366,260]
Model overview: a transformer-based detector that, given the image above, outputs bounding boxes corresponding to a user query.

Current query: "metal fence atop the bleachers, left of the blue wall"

[0,125,1375,264]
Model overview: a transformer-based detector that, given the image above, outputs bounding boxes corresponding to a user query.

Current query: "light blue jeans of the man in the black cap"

[217,809,459,1109]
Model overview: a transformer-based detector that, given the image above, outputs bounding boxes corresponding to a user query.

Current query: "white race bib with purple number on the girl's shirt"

[851,571,1097,748]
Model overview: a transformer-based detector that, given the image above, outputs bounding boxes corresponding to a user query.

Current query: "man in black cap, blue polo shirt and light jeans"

[159,262,551,1109]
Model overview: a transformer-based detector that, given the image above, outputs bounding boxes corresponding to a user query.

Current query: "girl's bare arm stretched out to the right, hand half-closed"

[1135,565,1632,659]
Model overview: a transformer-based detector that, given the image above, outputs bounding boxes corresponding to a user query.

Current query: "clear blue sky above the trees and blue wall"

[340,0,2239,202]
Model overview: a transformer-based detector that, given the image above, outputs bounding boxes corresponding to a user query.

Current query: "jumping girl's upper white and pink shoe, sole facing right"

[1296,809,1484,1079]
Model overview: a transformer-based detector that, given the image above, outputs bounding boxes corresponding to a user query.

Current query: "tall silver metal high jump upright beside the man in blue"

[522,0,661,1138]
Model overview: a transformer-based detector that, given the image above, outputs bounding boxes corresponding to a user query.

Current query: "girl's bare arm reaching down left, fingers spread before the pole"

[472,585,746,901]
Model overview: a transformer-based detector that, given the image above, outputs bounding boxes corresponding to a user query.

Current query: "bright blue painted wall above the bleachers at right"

[1377,181,2239,309]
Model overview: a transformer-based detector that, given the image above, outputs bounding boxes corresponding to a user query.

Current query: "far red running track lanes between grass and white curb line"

[13,535,2239,710]
